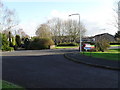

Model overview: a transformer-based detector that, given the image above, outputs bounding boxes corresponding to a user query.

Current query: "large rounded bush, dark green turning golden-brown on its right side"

[28,38,54,50]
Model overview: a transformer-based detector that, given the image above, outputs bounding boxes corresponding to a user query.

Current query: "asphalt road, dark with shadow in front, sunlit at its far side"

[2,49,118,88]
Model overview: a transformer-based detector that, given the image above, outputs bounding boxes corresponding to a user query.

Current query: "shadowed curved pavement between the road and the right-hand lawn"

[64,53,120,70]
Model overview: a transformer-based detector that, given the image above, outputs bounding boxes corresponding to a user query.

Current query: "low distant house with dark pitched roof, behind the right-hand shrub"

[82,33,115,42]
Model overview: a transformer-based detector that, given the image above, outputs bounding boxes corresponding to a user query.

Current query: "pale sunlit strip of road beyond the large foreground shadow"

[1,49,78,56]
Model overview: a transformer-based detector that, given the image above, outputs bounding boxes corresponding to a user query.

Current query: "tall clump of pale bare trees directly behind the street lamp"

[47,18,86,43]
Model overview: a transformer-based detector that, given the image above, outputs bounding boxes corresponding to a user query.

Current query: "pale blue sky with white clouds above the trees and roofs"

[4,0,117,36]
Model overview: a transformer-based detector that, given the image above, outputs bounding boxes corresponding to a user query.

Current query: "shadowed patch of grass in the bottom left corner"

[0,80,25,90]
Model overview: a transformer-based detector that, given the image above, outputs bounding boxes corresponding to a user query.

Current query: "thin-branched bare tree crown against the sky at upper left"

[0,1,18,31]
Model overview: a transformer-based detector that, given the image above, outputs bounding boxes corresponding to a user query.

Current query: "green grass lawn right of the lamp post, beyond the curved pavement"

[82,49,120,61]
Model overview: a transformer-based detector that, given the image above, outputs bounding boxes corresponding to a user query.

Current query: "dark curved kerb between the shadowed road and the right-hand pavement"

[64,53,120,70]
